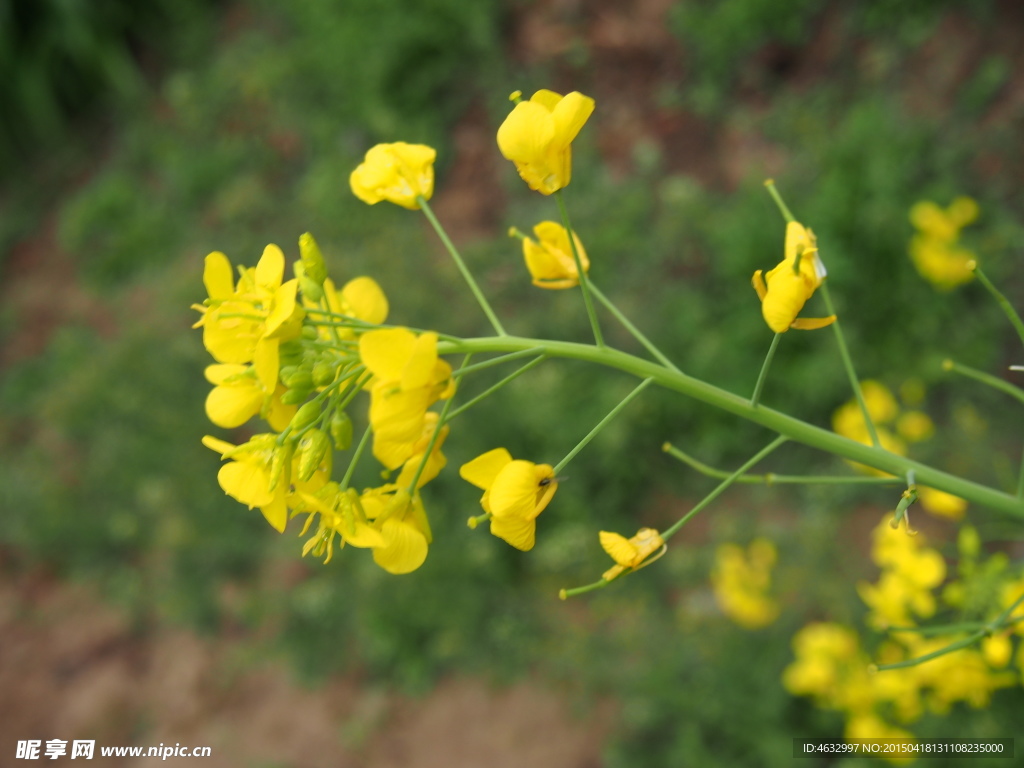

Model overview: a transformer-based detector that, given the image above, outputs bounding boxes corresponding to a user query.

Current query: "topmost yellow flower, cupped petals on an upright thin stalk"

[498,90,594,195]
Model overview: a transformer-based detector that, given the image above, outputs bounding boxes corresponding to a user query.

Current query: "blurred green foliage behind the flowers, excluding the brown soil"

[0,0,1024,768]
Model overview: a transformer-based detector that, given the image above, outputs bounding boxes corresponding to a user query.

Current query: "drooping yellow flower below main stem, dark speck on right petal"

[459,449,558,551]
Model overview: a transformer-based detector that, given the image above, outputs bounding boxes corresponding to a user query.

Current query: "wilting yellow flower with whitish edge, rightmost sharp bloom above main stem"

[751,221,836,334]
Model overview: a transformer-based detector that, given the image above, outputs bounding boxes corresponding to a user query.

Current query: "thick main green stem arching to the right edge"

[437,336,1024,518]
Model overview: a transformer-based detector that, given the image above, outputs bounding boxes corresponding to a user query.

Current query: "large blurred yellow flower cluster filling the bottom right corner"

[782,519,1024,757]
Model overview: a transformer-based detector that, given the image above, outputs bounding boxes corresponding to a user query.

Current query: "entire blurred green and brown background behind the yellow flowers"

[0,0,1024,768]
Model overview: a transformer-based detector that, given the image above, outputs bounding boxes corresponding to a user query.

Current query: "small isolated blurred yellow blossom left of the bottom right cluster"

[711,539,778,630]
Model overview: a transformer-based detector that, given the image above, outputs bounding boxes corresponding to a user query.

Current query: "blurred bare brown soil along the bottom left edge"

[0,570,611,768]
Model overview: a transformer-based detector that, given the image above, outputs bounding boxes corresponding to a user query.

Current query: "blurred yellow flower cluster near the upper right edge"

[910,197,978,291]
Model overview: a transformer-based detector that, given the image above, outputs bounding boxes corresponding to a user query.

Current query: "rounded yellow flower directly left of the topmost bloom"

[348,141,437,210]
